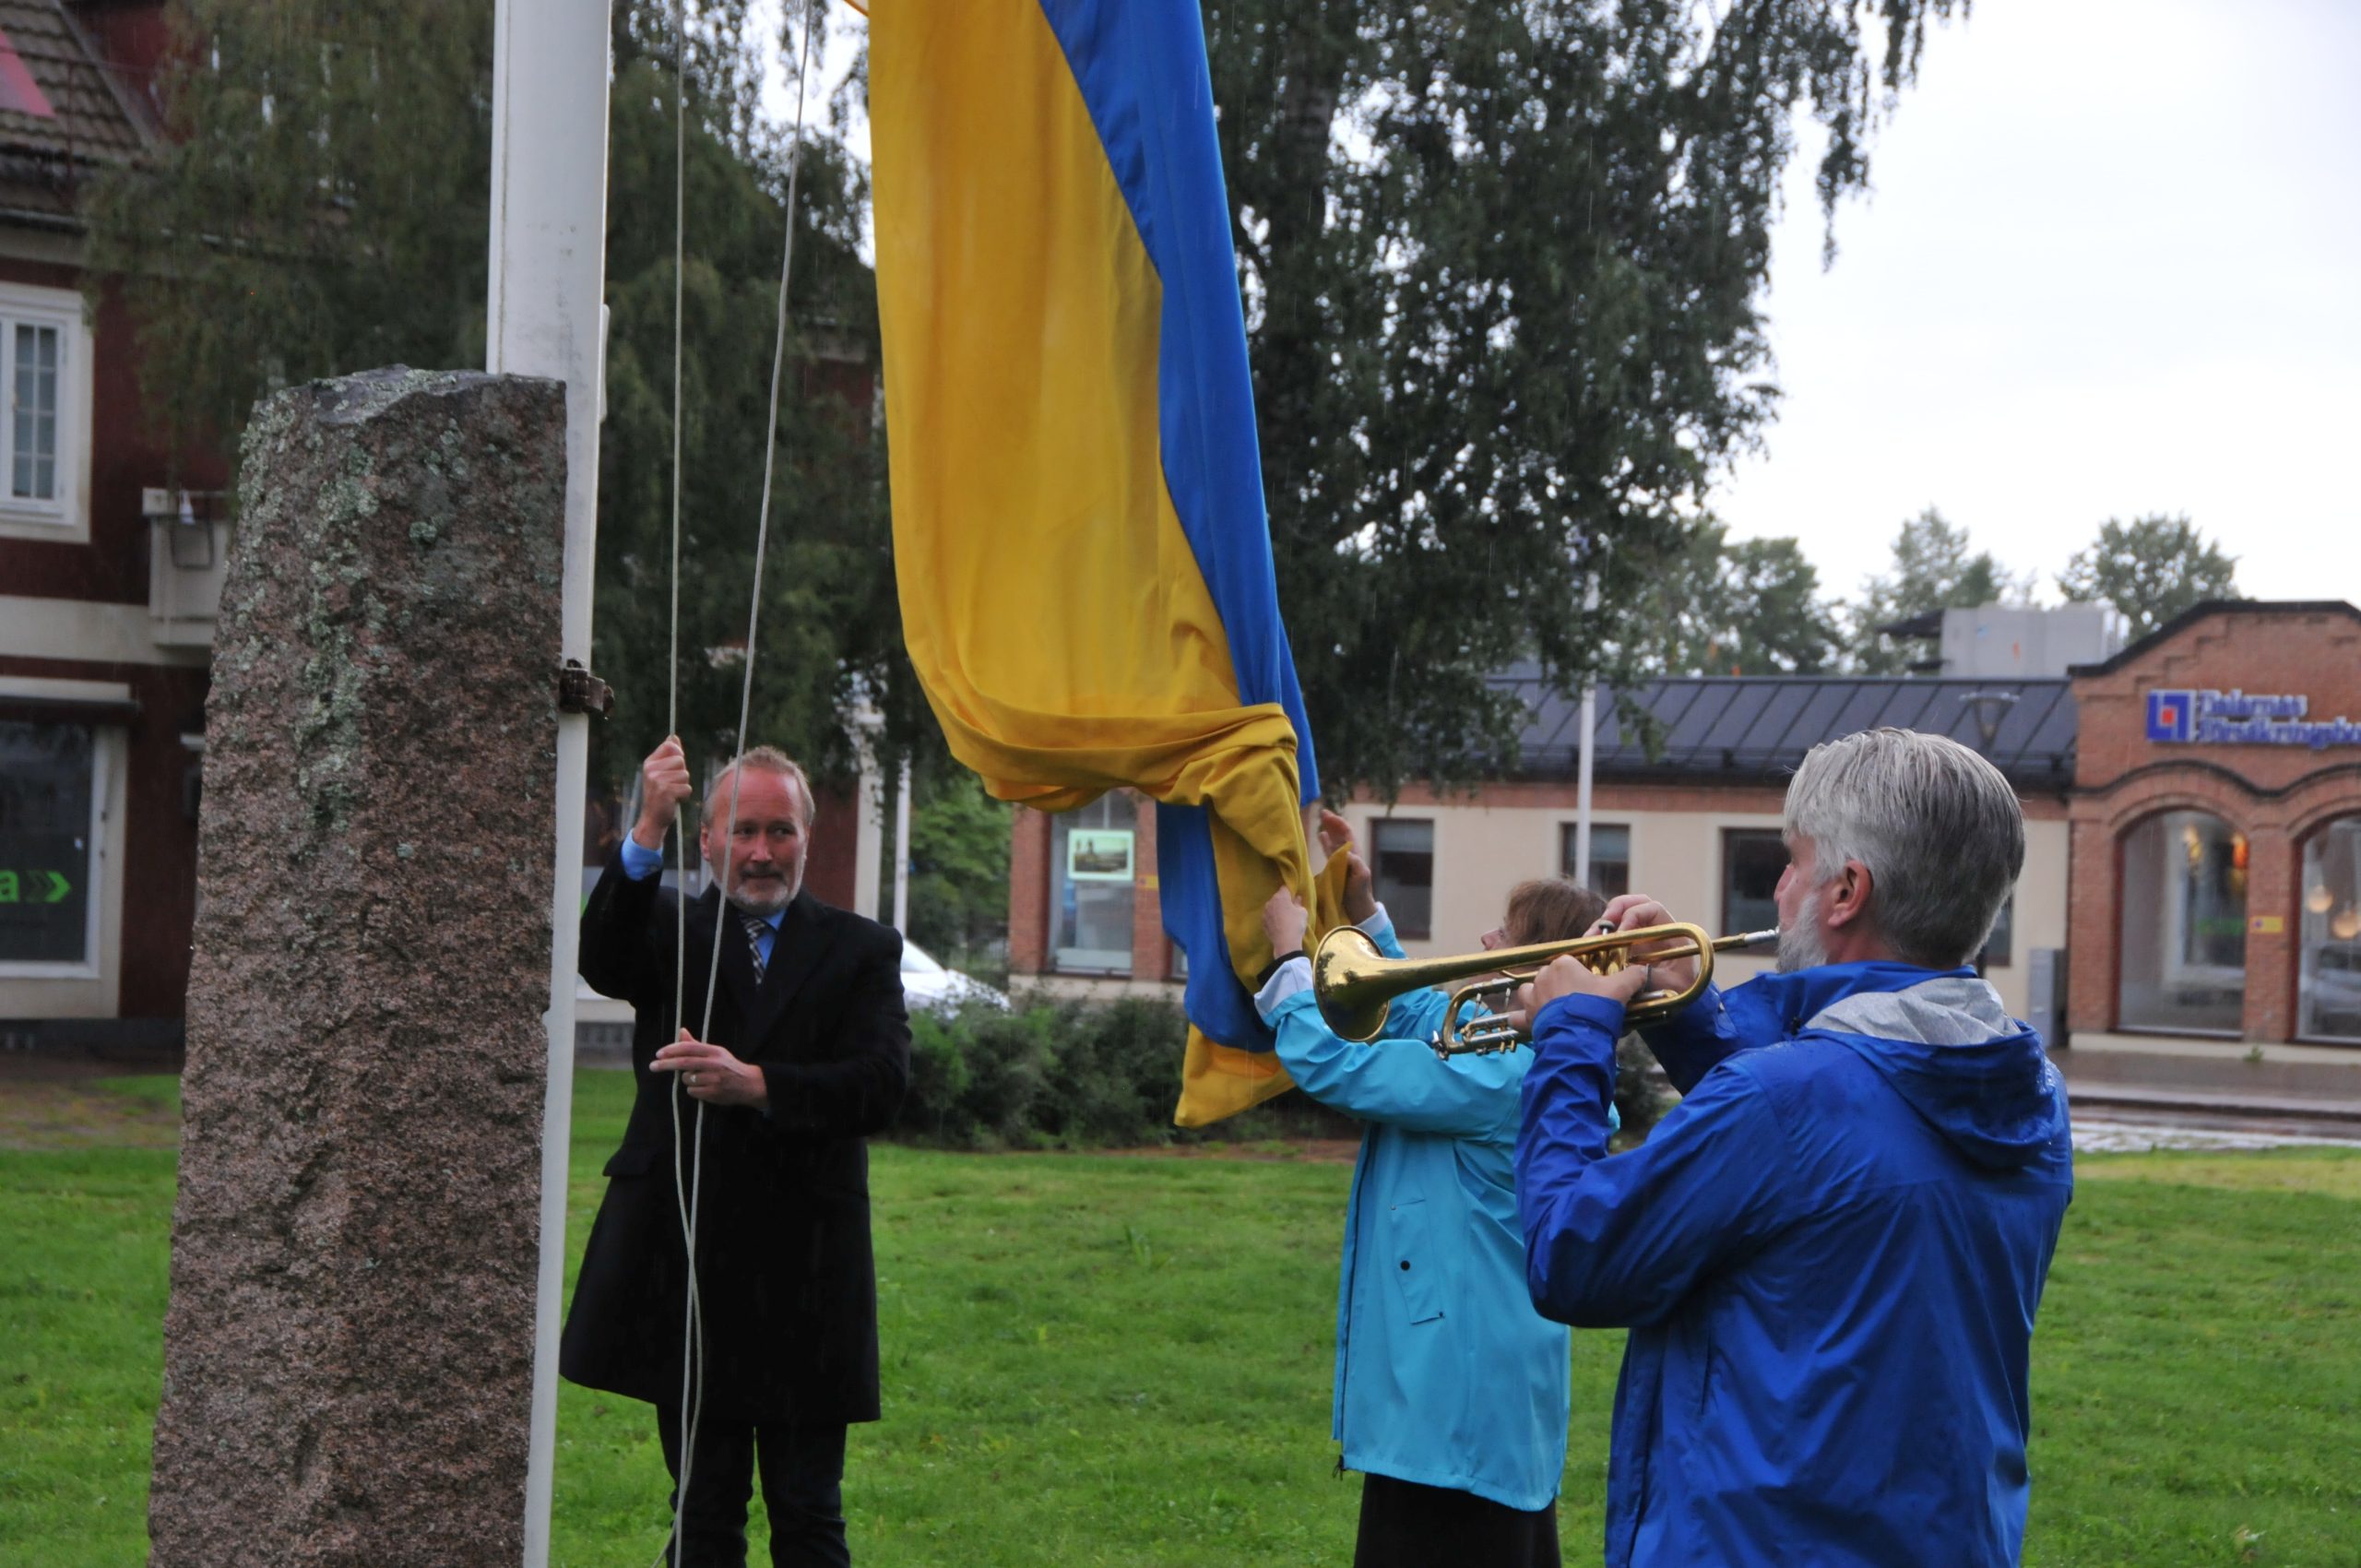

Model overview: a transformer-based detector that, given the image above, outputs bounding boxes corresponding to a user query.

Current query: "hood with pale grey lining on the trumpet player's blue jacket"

[1754,964,2066,1169]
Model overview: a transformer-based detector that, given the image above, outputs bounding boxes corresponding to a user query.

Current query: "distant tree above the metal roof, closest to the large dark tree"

[1629,522,1842,675]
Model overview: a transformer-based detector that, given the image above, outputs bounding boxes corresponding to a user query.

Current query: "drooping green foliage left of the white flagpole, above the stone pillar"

[85,0,491,451]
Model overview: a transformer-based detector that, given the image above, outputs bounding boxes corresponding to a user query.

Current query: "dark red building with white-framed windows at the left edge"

[0,0,212,1049]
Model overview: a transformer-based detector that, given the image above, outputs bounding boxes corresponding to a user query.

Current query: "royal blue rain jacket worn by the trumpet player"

[1516,964,2073,1568]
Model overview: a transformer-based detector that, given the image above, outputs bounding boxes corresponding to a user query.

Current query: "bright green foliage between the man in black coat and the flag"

[888,760,1015,970]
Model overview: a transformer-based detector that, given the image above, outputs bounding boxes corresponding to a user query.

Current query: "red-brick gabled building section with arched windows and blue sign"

[2069,602,2361,1044]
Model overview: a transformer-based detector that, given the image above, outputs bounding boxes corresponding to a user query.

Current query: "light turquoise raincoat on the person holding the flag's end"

[1270,926,1570,1512]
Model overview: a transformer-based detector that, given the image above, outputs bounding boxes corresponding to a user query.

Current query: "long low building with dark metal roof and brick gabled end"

[1008,602,2361,1053]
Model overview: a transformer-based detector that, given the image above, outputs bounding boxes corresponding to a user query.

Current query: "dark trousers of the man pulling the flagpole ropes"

[657,1405,852,1568]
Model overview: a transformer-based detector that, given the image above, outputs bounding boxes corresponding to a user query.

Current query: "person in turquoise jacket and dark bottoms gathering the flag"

[1256,814,1606,1568]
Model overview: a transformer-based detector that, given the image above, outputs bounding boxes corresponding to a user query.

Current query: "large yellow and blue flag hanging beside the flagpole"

[869,0,1334,1126]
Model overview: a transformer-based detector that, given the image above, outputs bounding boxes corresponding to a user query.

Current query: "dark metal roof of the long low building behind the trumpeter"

[1492,666,2075,791]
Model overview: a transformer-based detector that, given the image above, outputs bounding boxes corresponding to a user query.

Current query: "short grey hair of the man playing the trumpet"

[1787,730,2025,968]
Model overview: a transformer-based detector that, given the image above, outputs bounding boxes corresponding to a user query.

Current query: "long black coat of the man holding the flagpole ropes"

[560,852,909,1421]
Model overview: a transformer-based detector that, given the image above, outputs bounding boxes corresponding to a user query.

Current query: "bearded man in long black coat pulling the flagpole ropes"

[560,739,909,1568]
